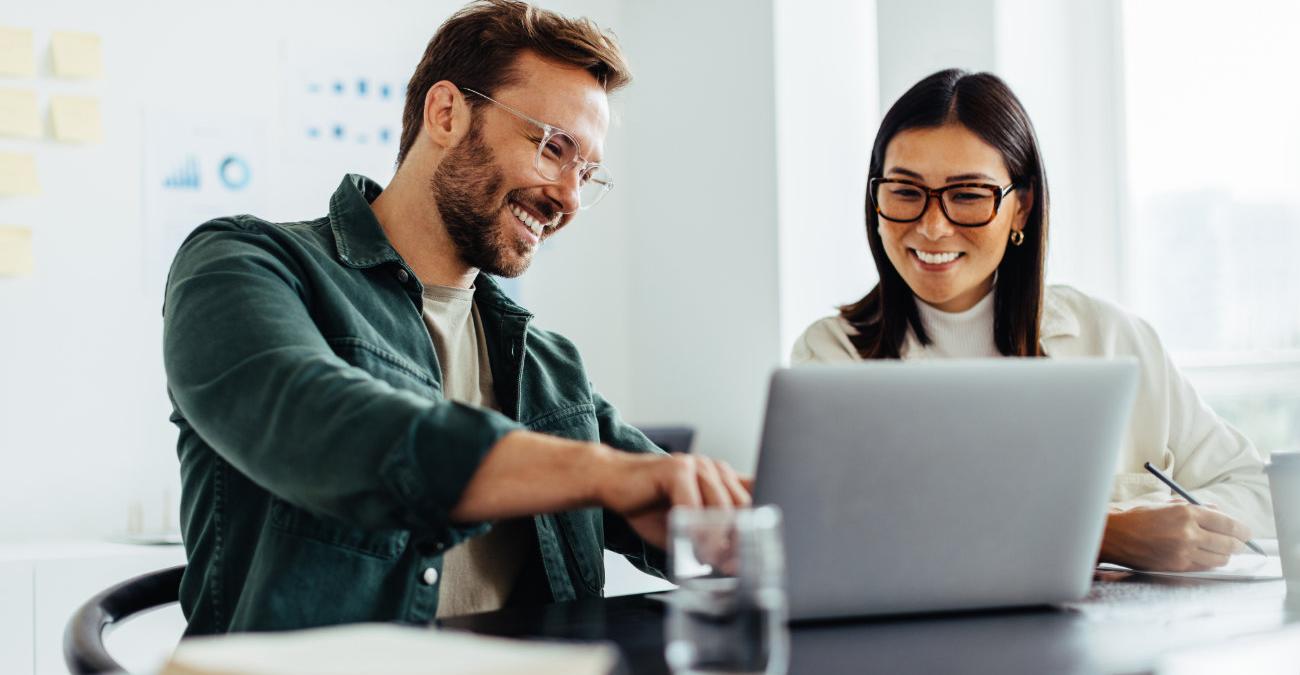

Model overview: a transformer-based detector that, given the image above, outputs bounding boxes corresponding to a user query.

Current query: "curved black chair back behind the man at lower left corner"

[64,564,185,675]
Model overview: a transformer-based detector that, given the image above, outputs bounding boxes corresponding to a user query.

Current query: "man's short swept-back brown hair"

[398,0,632,164]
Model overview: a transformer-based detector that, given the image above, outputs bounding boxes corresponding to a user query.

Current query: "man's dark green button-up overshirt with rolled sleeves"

[163,176,662,635]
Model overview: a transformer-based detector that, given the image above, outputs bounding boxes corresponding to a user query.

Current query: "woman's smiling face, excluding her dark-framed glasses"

[878,122,1034,312]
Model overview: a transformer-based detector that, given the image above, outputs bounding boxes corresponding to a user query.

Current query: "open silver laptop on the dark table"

[754,359,1138,619]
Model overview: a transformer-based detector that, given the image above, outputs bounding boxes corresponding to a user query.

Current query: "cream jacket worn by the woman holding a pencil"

[790,286,1275,537]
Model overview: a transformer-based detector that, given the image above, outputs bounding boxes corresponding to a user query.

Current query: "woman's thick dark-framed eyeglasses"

[867,178,1015,228]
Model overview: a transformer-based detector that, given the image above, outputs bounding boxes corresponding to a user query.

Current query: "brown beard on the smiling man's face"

[429,120,533,277]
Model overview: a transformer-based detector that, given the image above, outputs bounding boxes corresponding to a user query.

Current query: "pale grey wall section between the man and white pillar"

[619,0,780,470]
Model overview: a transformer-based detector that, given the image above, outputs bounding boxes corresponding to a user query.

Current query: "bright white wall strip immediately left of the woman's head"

[776,0,880,359]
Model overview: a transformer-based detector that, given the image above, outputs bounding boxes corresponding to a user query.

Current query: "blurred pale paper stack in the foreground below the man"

[163,623,618,675]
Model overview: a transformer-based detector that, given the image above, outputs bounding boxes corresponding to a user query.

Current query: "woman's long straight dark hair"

[840,69,1048,359]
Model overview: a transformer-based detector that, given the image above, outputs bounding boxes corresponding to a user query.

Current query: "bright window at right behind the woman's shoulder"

[1123,0,1300,451]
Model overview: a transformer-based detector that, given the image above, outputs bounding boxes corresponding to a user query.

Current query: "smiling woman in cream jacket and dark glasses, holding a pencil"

[792,70,1273,571]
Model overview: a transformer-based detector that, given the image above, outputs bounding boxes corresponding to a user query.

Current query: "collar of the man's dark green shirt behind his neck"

[329,173,402,269]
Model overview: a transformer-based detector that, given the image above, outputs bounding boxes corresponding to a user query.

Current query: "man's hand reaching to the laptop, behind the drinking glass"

[597,451,751,549]
